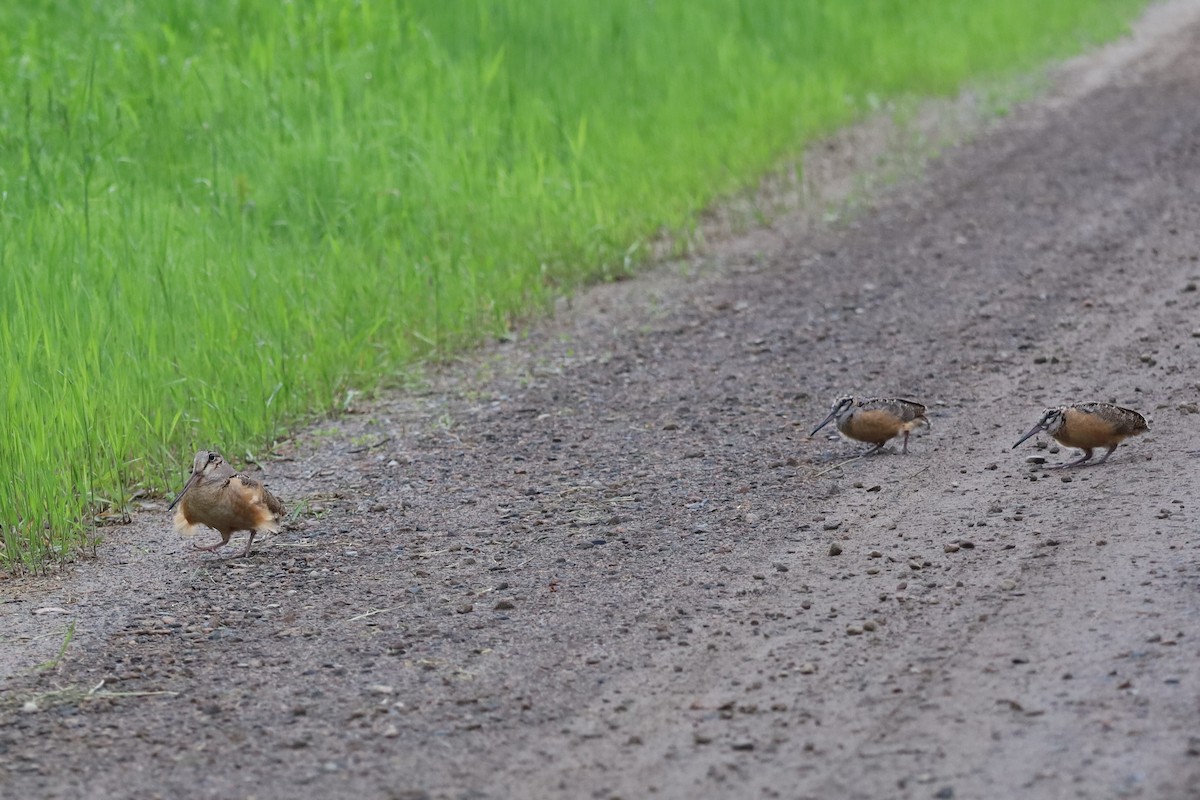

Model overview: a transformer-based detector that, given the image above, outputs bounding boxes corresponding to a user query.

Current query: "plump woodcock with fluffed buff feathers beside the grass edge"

[167,450,284,555]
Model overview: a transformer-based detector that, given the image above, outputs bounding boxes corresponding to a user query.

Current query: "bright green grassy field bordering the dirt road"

[0,0,1144,569]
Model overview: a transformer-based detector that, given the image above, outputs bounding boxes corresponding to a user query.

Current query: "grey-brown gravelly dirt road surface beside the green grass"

[0,2,1200,800]
